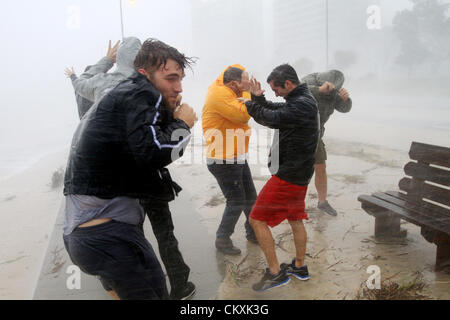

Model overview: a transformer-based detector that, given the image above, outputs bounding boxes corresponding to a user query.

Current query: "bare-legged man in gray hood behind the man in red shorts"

[302,70,352,216]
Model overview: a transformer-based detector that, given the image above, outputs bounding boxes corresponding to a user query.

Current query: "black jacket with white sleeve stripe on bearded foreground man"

[64,74,190,201]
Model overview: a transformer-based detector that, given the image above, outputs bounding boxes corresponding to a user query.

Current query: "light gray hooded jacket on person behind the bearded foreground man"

[72,37,142,103]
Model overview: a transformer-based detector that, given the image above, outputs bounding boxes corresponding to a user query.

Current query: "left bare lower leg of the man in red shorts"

[250,218,281,275]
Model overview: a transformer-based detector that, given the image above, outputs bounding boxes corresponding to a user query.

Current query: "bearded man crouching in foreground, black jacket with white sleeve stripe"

[64,39,197,299]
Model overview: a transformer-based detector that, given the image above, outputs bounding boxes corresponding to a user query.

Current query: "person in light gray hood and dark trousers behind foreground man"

[66,37,195,300]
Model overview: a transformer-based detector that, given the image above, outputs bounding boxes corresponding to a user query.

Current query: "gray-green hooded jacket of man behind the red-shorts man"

[302,70,352,137]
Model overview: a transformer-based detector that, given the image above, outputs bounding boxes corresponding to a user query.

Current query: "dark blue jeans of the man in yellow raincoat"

[208,162,257,238]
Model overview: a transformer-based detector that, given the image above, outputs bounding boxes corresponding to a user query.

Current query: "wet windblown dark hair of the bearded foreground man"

[134,38,197,72]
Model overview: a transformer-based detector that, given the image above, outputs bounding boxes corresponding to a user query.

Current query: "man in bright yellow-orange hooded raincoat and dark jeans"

[202,65,258,255]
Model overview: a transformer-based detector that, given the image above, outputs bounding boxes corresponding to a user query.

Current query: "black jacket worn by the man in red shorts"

[246,84,320,186]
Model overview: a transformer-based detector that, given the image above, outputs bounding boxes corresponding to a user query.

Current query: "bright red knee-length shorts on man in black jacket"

[250,176,308,228]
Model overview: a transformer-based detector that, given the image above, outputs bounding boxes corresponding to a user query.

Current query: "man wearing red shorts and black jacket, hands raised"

[246,64,320,291]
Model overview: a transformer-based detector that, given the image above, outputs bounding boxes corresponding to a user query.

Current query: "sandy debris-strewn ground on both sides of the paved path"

[0,140,450,299]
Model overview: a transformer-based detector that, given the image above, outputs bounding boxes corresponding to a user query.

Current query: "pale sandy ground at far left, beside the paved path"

[0,151,67,299]
